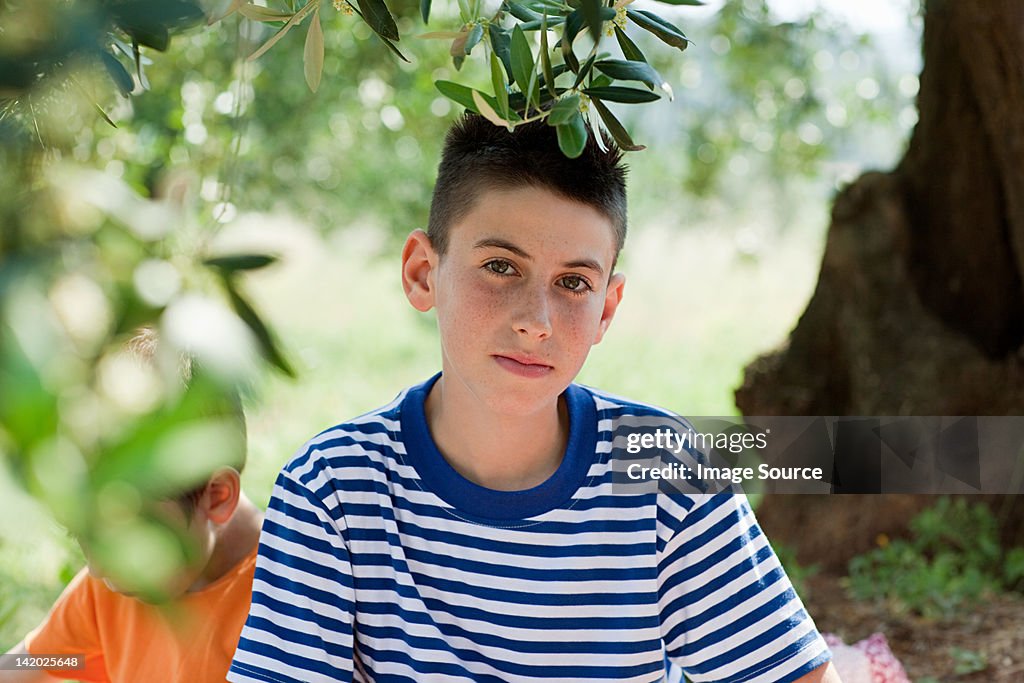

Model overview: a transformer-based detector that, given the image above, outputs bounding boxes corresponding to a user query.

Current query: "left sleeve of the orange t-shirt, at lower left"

[25,569,108,682]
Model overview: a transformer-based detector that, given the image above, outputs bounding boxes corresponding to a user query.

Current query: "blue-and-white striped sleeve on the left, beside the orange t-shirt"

[227,461,354,683]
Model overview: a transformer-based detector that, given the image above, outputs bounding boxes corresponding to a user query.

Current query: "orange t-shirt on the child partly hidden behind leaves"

[26,549,256,683]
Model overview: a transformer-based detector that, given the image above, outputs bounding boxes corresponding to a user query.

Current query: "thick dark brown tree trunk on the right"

[736,0,1024,564]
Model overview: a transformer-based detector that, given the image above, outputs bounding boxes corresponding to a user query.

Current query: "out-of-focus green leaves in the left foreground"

[0,0,303,597]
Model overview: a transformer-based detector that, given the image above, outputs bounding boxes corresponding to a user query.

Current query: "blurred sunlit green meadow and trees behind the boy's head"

[0,0,920,651]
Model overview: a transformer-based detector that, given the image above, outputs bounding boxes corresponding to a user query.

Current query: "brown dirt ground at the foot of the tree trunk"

[804,574,1024,683]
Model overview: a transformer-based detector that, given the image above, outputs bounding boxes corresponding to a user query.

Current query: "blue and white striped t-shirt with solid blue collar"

[227,377,829,683]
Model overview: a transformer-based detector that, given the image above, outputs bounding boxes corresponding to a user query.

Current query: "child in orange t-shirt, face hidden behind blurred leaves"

[0,331,262,683]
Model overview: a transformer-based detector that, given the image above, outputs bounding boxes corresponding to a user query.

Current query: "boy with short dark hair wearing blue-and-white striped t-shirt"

[228,116,838,683]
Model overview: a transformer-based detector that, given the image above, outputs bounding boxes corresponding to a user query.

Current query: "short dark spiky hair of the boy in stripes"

[427,112,627,258]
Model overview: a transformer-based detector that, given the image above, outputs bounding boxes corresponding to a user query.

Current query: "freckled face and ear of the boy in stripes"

[402,186,625,415]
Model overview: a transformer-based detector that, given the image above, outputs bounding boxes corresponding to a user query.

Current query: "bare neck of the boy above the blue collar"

[423,375,569,490]
